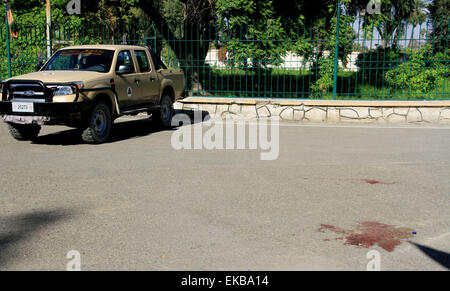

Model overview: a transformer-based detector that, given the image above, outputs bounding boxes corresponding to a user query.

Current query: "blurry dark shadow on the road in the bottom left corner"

[0,209,74,268]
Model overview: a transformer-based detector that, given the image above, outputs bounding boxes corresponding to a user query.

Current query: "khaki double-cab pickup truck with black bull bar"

[0,45,185,144]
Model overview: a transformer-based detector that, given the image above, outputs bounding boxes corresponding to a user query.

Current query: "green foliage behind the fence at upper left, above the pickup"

[0,0,153,79]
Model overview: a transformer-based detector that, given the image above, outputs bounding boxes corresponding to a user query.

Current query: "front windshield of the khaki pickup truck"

[42,49,114,73]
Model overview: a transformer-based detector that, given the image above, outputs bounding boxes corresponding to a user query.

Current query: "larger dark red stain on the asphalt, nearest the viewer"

[318,221,413,252]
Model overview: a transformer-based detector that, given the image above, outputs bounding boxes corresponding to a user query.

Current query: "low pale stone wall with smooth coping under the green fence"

[175,97,450,124]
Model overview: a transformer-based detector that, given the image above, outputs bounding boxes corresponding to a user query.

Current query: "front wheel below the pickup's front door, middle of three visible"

[81,103,112,144]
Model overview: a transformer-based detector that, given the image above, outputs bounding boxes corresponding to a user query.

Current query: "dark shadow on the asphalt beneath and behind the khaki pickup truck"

[33,110,208,146]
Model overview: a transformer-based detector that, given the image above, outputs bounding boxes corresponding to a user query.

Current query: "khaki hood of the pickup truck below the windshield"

[6,71,108,84]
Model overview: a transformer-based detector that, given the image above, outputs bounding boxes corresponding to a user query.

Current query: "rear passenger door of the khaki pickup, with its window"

[134,48,160,104]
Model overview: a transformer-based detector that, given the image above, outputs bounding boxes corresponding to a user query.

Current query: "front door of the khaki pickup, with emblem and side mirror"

[114,50,140,108]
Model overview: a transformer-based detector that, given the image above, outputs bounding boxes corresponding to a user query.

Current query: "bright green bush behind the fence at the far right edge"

[385,45,450,93]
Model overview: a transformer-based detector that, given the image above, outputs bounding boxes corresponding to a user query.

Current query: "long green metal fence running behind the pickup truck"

[0,20,450,100]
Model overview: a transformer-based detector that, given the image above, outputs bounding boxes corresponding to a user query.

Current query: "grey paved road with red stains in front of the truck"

[0,120,450,270]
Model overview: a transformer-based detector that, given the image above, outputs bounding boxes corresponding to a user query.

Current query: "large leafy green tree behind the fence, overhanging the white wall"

[216,0,354,68]
